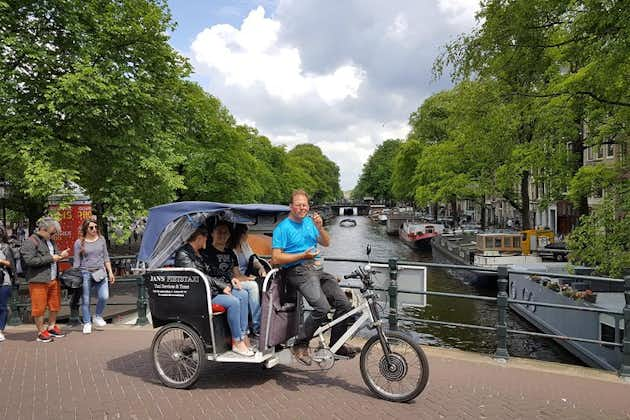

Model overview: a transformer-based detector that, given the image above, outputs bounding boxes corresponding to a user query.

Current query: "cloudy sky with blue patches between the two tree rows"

[169,0,479,190]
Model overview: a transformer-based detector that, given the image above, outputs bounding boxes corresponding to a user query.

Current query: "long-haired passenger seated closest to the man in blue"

[228,224,267,335]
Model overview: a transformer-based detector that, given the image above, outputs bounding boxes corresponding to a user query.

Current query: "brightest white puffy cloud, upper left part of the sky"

[191,6,366,105]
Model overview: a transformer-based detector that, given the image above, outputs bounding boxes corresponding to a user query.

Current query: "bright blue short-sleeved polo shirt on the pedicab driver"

[271,216,319,268]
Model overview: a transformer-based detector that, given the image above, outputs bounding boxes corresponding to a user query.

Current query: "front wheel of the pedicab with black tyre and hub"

[359,331,429,402]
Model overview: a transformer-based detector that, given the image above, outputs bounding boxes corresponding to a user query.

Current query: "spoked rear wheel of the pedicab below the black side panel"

[151,322,207,388]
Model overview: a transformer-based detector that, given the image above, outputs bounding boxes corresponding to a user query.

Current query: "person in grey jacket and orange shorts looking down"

[20,217,70,343]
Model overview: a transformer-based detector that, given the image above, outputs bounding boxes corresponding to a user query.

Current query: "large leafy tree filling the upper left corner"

[0,0,189,238]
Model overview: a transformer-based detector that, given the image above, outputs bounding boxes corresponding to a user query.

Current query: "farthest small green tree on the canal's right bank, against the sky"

[352,140,401,201]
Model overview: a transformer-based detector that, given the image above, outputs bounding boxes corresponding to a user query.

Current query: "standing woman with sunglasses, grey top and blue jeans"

[73,219,116,334]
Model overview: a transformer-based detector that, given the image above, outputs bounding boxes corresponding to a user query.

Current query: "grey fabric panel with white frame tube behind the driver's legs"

[259,269,299,350]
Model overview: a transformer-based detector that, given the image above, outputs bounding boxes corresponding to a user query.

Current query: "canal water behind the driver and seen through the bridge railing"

[323,216,582,365]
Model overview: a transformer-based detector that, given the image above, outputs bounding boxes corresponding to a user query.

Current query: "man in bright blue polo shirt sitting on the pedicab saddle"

[271,190,359,365]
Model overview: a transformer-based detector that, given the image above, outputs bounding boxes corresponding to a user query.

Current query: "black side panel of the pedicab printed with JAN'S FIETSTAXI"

[144,267,232,353]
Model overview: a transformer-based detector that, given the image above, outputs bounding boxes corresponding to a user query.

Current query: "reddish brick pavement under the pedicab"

[0,326,630,420]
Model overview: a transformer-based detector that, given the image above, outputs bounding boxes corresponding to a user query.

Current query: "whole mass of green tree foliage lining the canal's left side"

[0,0,341,239]
